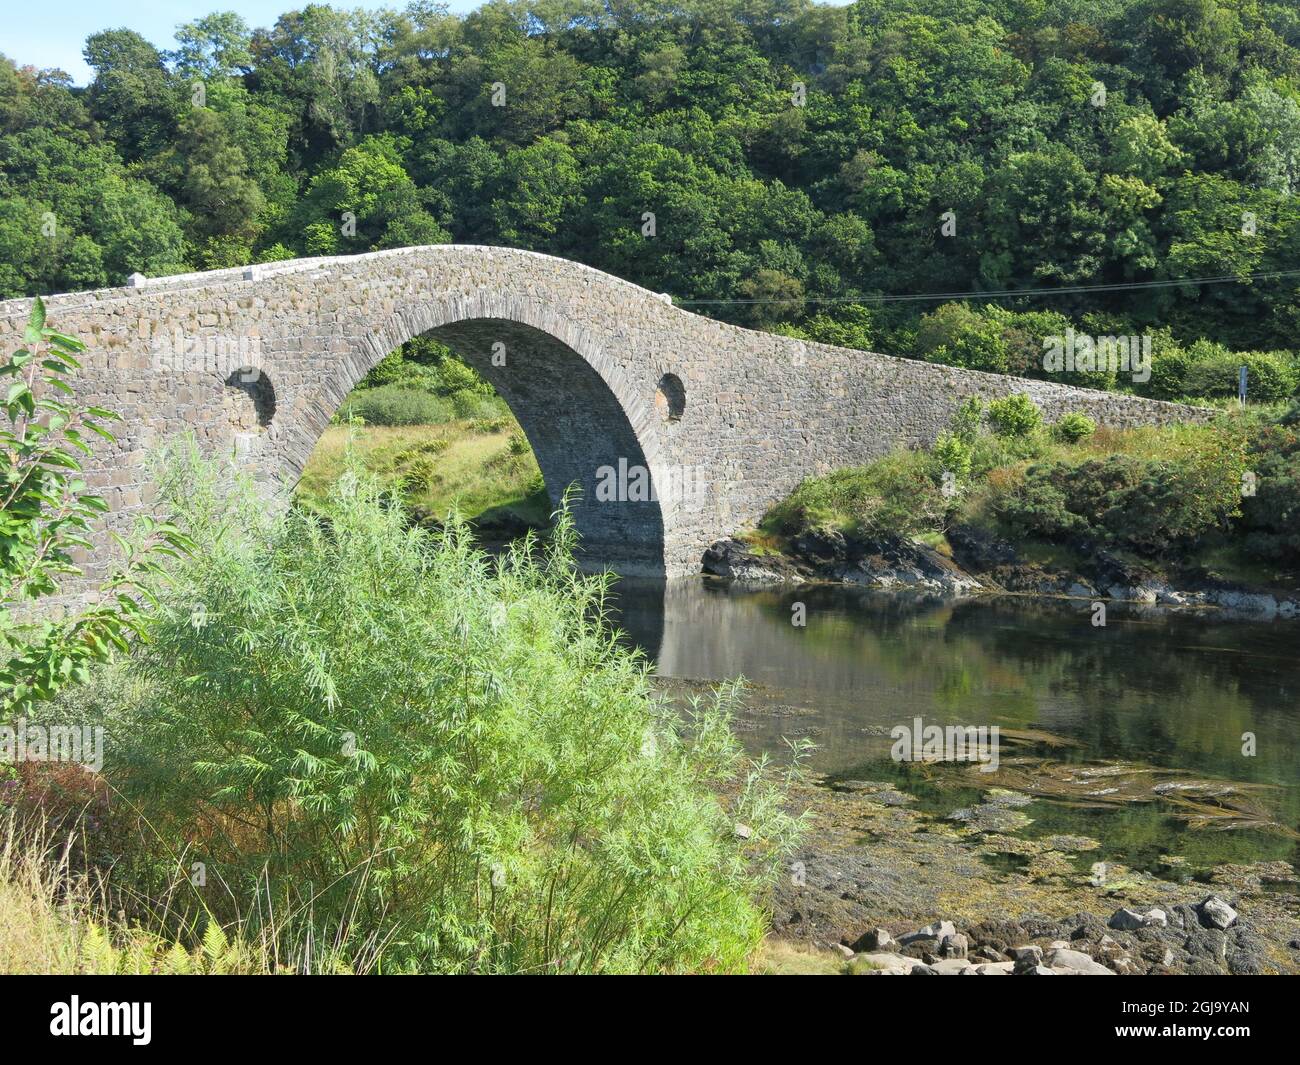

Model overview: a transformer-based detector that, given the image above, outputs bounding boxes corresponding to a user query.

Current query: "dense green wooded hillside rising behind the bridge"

[0,0,1300,399]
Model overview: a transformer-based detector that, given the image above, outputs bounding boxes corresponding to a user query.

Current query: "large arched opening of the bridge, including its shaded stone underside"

[298,319,664,577]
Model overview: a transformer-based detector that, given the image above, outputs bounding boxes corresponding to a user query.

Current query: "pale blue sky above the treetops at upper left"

[0,0,478,85]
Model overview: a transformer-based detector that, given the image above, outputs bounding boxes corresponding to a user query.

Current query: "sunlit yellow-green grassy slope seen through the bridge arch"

[298,417,551,525]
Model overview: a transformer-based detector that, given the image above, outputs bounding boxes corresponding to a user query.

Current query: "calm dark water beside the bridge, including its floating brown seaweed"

[618,579,1300,875]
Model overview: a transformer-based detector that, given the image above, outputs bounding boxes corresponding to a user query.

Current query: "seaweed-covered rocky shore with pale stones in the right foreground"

[772,782,1300,975]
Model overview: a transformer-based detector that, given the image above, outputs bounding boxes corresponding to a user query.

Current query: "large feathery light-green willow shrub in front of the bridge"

[109,442,800,971]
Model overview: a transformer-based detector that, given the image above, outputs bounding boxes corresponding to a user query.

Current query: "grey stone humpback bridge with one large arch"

[0,244,1190,590]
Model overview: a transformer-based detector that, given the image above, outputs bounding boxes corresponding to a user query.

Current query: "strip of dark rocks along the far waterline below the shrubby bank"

[703,528,1300,620]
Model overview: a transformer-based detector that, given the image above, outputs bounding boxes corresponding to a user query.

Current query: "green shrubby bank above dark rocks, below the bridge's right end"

[748,395,1300,588]
